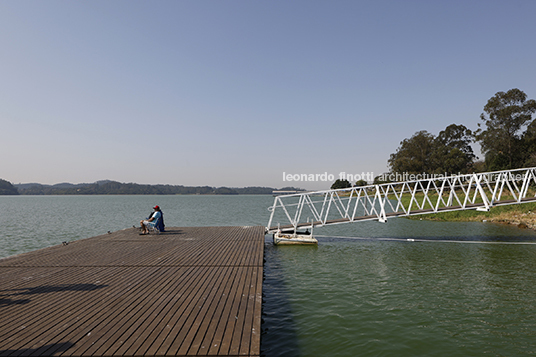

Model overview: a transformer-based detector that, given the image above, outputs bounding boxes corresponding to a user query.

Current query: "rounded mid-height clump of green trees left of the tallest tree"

[388,124,476,174]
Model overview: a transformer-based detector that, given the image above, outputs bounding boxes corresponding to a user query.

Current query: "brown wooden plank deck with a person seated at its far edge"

[0,227,264,356]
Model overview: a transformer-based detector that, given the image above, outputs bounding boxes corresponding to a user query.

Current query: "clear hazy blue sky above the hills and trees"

[0,0,536,189]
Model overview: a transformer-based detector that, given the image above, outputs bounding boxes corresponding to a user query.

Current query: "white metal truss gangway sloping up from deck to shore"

[266,167,536,233]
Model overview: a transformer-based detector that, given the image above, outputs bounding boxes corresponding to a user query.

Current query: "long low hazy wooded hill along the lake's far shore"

[11,180,304,195]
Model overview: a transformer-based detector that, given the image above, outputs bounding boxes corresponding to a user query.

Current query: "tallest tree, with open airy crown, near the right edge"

[476,88,536,170]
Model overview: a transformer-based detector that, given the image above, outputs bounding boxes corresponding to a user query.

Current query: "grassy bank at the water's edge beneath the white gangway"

[408,202,536,229]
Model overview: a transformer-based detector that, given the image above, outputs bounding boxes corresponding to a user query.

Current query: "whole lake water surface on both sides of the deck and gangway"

[0,196,536,356]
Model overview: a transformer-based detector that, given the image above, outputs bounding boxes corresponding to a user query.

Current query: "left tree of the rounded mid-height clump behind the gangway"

[388,130,435,174]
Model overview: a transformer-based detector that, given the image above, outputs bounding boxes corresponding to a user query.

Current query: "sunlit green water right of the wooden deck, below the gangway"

[263,220,536,356]
